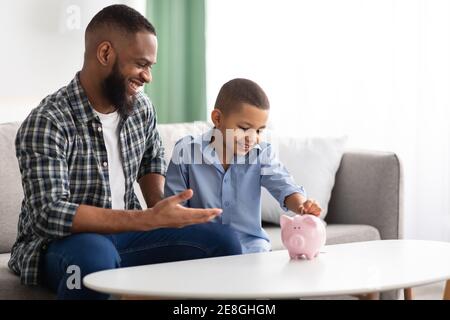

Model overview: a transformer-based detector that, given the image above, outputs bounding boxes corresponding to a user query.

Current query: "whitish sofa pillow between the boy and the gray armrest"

[262,132,346,224]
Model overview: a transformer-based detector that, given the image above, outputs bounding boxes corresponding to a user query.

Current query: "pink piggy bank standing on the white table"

[280,214,326,260]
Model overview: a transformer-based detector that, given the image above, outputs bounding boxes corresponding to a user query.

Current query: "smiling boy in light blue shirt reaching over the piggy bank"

[165,79,321,253]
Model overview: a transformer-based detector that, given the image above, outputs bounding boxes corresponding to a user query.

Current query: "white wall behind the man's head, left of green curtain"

[0,0,145,123]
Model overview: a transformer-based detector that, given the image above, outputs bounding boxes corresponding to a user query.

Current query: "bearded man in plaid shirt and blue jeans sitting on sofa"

[9,5,241,299]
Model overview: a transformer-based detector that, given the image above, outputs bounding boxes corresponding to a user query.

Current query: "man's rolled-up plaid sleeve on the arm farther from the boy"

[15,114,79,239]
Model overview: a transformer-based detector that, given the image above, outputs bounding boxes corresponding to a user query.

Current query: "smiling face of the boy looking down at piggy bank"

[211,103,269,155]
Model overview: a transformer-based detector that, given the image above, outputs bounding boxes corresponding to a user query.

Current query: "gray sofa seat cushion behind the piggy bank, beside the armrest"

[263,224,381,250]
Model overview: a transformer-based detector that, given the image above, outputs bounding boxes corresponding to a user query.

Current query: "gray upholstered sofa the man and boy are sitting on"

[0,123,401,299]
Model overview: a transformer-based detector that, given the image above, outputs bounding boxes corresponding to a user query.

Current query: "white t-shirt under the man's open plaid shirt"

[94,110,125,210]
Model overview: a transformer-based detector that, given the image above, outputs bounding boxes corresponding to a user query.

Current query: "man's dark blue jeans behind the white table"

[41,223,242,299]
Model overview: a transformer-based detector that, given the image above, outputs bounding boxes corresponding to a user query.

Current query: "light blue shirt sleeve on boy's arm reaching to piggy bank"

[260,145,306,211]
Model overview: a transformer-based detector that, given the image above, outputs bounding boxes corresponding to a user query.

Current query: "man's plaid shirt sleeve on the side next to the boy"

[137,103,167,181]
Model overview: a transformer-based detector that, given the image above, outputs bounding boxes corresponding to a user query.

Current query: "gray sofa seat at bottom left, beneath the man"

[0,254,55,300]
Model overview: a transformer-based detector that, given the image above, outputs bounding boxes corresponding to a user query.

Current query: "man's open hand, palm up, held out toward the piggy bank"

[145,189,222,229]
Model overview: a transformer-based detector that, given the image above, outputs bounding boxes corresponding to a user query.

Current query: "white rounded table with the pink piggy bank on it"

[83,240,450,299]
